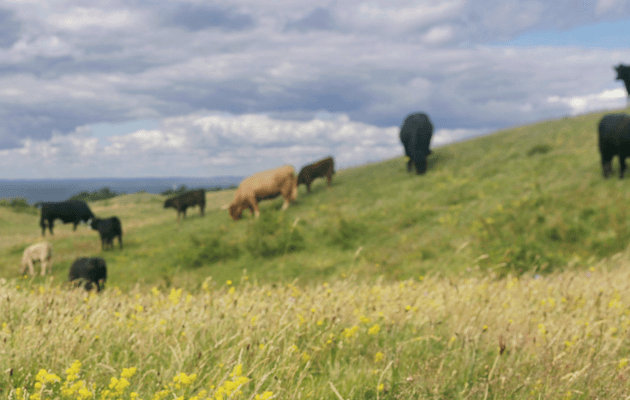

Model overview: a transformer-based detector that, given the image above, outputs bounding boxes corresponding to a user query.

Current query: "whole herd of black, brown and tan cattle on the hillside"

[14,86,630,291]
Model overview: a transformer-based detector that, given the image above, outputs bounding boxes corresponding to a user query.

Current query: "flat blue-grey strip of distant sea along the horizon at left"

[0,176,243,204]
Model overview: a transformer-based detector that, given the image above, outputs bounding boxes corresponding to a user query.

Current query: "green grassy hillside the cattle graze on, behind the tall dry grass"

[0,108,630,289]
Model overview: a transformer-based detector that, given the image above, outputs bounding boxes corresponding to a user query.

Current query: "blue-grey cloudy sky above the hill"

[0,0,630,179]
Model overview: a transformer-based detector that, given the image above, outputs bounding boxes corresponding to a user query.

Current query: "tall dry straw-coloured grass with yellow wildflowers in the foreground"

[0,254,630,400]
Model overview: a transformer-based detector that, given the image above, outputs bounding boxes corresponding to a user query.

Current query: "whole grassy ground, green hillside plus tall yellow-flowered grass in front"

[0,108,630,400]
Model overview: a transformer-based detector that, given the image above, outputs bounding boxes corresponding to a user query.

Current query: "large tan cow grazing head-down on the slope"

[224,165,297,221]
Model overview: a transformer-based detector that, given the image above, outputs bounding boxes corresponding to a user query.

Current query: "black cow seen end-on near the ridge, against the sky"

[400,113,433,174]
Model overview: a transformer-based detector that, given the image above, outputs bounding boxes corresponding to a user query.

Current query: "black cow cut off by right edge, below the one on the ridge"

[598,114,630,179]
